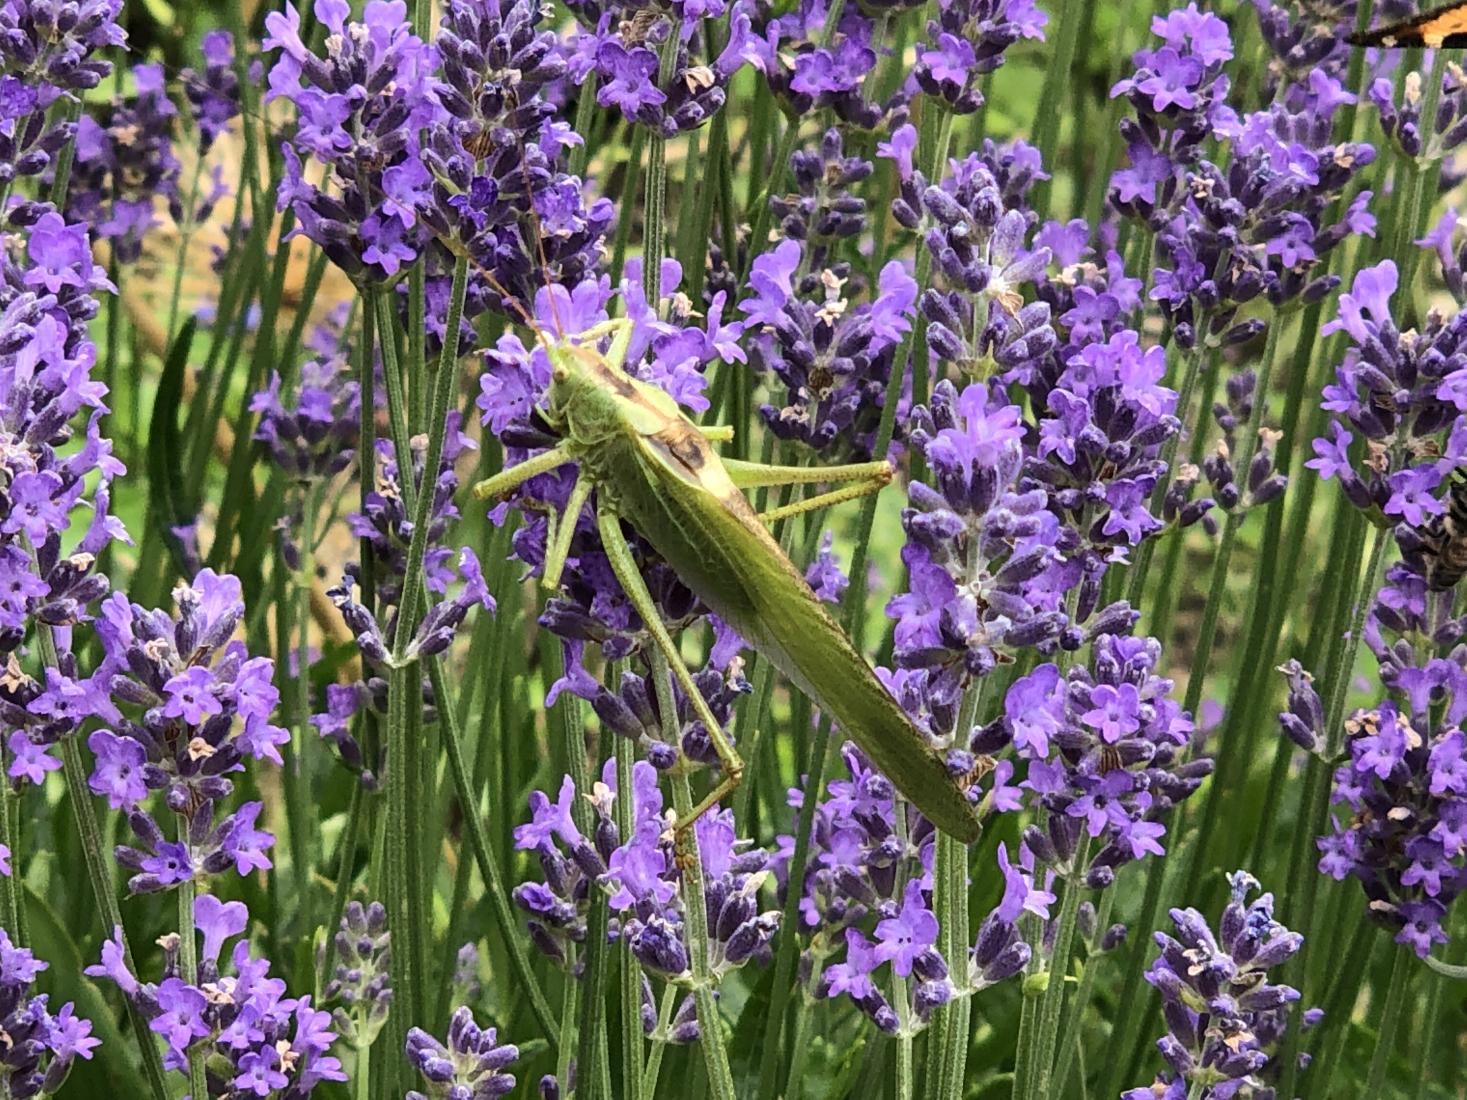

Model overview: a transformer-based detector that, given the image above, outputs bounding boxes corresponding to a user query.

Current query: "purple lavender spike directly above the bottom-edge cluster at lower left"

[87,569,290,893]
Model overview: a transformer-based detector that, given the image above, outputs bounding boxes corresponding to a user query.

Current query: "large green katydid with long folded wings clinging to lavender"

[474,318,980,840]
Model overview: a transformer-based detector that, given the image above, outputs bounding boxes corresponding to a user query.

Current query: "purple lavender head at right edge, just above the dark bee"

[1304,260,1467,528]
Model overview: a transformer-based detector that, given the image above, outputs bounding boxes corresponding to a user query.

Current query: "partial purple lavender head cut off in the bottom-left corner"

[0,928,101,1100]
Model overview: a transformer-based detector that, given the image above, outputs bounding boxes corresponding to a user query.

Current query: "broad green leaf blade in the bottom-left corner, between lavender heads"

[25,887,148,1100]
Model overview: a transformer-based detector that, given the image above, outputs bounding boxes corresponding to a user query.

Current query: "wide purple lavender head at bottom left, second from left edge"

[87,893,346,1100]
